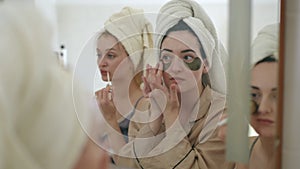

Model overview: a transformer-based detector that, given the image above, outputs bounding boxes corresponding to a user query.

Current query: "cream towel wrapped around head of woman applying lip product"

[100,7,154,70]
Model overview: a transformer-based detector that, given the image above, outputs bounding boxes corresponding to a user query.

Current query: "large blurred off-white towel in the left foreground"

[0,3,88,169]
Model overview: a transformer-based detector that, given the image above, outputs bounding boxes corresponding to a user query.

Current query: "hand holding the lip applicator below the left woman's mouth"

[95,86,117,123]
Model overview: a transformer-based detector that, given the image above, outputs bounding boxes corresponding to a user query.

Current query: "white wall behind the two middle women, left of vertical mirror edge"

[56,1,228,90]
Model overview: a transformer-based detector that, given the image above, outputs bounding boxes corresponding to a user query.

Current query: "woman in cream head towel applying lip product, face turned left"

[96,7,155,167]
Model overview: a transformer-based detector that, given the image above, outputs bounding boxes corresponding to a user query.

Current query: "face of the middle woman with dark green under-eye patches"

[160,31,204,92]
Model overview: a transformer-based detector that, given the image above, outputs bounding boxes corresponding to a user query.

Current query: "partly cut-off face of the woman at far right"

[251,62,278,137]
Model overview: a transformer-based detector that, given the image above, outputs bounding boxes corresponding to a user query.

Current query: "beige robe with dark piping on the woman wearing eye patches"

[116,87,233,169]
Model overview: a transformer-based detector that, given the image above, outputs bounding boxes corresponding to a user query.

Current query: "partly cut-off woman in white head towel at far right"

[239,24,279,169]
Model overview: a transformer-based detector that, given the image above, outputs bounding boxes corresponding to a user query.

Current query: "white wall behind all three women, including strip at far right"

[56,0,278,90]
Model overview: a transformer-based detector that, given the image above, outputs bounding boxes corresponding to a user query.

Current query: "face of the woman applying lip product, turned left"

[97,34,127,81]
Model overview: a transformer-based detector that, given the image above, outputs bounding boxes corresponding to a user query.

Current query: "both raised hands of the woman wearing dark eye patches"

[143,62,180,133]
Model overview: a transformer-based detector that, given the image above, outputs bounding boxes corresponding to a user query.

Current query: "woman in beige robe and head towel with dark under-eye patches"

[126,0,233,169]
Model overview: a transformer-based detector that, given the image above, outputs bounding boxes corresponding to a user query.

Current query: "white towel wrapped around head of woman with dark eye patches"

[155,0,227,94]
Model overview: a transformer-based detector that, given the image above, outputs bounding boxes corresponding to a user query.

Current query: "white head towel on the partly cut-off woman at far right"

[251,23,279,67]
